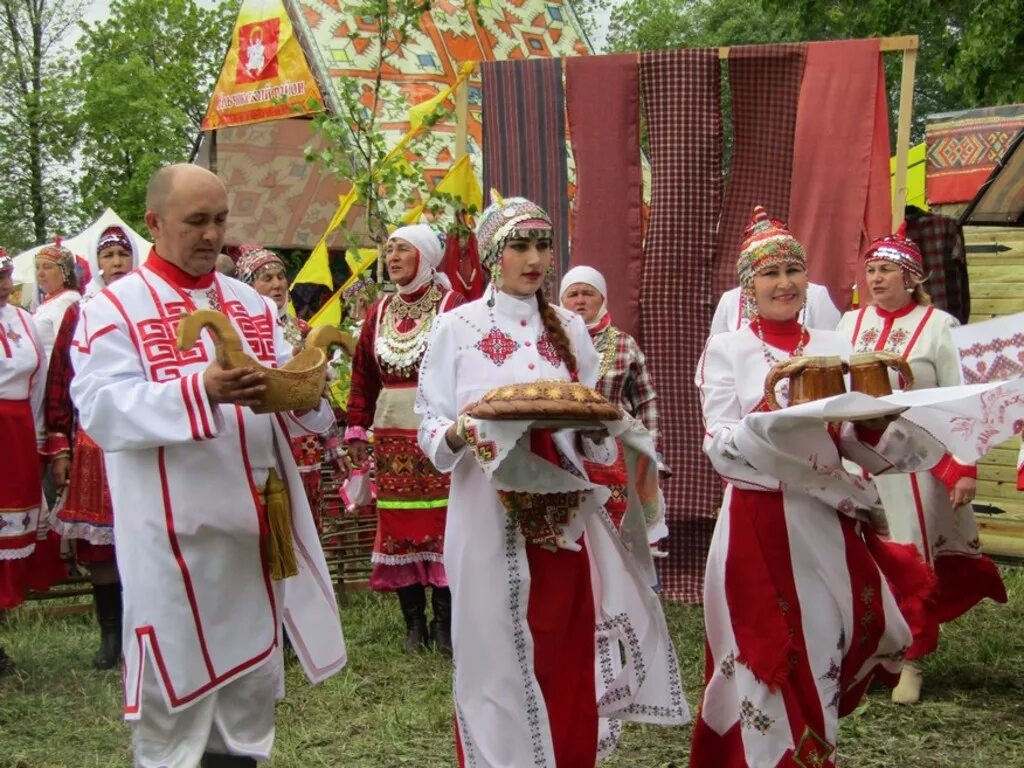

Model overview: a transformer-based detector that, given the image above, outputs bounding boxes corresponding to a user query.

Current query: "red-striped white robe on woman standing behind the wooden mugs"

[838,301,1007,638]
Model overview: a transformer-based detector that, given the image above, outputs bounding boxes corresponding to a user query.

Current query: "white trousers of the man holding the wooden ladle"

[132,648,285,768]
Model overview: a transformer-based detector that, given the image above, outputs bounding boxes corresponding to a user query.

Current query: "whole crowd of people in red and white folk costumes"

[0,159,1007,768]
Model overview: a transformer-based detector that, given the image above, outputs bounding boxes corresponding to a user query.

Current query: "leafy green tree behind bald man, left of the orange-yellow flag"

[80,0,238,228]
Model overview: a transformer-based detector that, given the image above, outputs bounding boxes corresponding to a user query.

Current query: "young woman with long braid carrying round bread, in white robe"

[417,198,688,768]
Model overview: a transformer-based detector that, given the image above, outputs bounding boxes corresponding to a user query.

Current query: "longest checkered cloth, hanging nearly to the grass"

[639,49,722,603]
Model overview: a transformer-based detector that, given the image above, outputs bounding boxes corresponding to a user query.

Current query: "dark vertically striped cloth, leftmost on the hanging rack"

[480,58,569,286]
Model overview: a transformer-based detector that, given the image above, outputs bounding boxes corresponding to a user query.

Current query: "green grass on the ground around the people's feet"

[0,568,1024,768]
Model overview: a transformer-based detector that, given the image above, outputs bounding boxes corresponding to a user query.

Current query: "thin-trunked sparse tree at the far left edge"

[0,0,81,250]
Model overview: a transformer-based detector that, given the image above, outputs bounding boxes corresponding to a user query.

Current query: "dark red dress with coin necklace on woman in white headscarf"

[345,283,464,591]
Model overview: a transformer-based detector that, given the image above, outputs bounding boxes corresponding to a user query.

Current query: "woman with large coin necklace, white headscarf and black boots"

[345,224,463,655]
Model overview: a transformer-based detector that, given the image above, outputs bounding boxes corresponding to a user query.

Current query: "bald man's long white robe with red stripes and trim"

[72,254,345,719]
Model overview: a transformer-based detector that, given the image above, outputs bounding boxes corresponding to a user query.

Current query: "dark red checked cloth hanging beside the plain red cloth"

[713,45,806,298]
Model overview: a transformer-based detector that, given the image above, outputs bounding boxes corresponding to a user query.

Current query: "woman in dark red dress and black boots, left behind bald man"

[45,226,135,670]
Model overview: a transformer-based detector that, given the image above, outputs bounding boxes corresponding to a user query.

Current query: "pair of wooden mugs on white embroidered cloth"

[765,352,913,411]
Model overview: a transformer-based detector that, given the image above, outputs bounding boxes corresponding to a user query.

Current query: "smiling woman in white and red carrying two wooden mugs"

[690,207,938,768]
